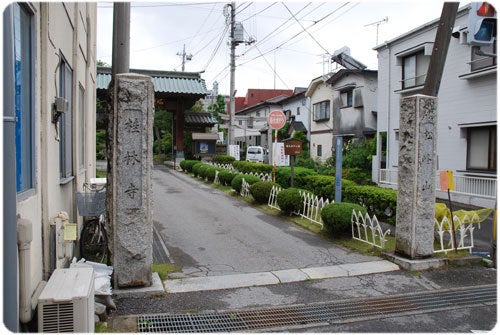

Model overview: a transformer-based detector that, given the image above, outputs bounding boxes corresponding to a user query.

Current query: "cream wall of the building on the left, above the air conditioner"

[12,2,97,310]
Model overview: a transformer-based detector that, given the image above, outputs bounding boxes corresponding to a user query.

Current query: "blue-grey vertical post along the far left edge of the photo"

[3,5,19,333]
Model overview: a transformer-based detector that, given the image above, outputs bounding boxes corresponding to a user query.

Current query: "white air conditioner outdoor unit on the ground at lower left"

[38,268,95,333]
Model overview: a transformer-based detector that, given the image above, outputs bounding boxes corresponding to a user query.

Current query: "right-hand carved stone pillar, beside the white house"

[395,95,437,259]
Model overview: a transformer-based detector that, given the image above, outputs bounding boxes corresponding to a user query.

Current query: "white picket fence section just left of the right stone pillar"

[351,209,391,249]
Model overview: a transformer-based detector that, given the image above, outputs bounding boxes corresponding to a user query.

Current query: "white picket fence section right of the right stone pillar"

[434,214,481,253]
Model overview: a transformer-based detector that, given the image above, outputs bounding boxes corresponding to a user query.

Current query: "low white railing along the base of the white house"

[379,169,497,199]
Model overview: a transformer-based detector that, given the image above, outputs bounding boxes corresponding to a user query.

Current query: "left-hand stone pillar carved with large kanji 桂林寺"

[107,73,154,287]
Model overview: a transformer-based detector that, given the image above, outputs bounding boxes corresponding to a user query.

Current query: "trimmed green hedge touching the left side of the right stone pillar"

[342,186,398,224]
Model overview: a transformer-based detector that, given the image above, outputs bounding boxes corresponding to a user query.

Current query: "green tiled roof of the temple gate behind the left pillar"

[97,67,210,95]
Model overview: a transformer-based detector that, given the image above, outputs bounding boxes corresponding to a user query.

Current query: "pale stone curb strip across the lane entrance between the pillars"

[163,260,399,293]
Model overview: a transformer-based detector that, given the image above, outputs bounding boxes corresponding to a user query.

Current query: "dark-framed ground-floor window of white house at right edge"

[467,126,497,172]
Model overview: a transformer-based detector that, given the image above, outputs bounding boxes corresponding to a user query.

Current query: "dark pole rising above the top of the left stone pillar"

[111,2,130,78]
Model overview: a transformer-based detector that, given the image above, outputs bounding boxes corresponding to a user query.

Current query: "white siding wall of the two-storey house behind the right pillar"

[377,7,497,203]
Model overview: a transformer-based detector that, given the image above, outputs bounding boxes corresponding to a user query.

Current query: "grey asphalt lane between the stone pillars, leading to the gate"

[153,168,390,290]
